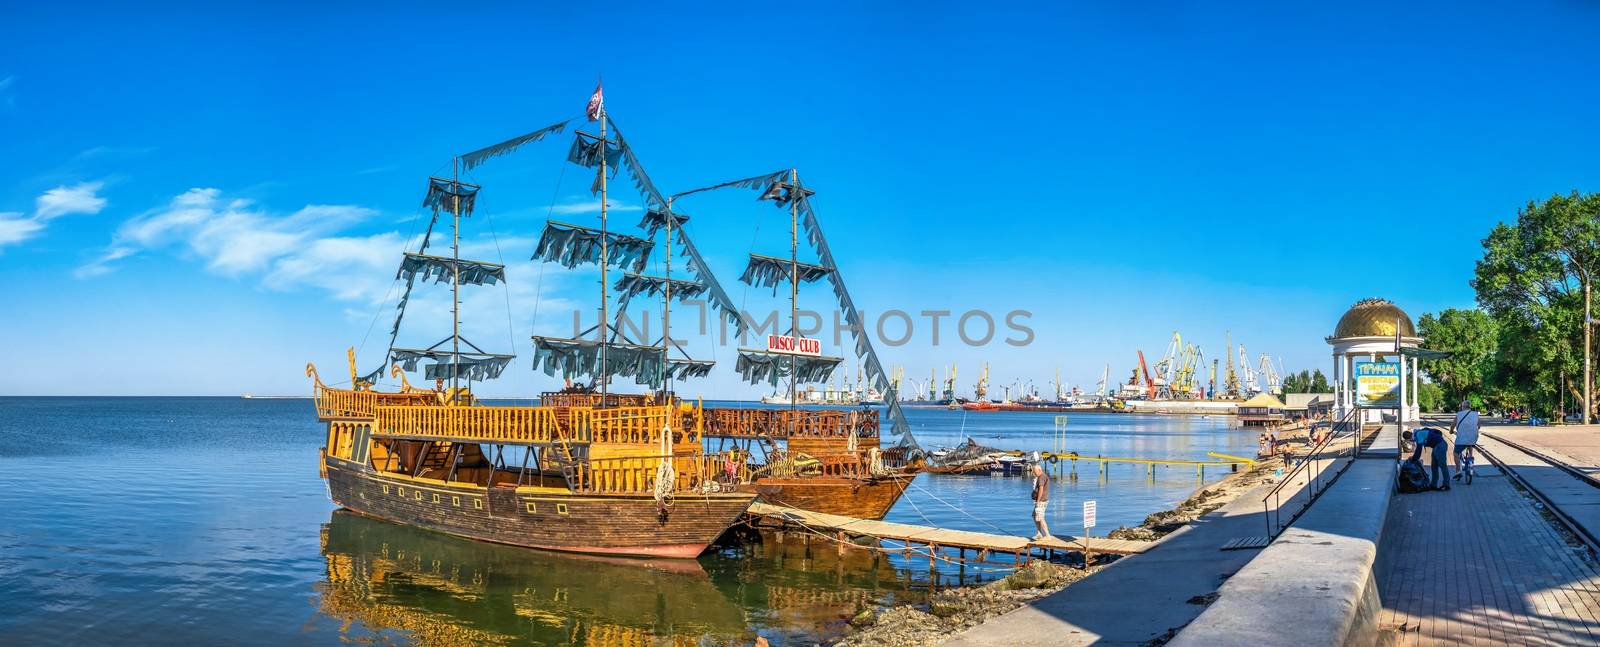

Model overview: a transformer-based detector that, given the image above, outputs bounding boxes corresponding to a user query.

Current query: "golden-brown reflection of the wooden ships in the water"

[318,511,926,645]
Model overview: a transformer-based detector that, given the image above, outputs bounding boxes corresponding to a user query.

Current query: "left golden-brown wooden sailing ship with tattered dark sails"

[318,88,754,557]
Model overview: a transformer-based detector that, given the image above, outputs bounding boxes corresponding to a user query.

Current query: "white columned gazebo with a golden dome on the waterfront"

[1326,299,1422,426]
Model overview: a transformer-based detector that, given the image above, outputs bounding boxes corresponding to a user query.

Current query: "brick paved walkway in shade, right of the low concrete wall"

[1379,452,1600,645]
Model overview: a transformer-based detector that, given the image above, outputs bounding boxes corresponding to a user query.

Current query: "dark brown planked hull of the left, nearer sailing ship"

[326,458,754,559]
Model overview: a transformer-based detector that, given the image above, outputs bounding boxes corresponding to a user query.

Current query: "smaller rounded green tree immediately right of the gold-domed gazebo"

[1418,307,1499,402]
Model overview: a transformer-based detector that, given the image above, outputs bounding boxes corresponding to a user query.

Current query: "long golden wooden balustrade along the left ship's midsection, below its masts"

[373,407,576,444]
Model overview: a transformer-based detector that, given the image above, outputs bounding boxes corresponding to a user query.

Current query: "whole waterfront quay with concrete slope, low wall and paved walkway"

[947,420,1600,645]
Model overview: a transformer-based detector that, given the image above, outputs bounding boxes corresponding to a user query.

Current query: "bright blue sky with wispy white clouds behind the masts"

[0,2,1600,396]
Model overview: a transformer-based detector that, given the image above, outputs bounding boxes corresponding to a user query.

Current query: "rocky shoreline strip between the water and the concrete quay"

[834,458,1283,647]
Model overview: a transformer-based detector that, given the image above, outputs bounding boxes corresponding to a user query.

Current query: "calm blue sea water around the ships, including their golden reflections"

[0,397,1254,645]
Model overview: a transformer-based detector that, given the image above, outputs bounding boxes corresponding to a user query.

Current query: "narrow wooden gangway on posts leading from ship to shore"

[749,503,1155,564]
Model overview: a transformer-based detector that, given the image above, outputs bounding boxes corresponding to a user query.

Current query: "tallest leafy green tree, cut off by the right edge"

[1472,192,1600,412]
